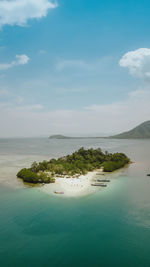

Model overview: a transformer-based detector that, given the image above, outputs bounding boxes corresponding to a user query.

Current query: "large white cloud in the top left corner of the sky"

[0,0,57,27]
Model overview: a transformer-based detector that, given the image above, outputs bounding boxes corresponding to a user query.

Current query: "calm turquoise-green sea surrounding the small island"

[0,139,150,267]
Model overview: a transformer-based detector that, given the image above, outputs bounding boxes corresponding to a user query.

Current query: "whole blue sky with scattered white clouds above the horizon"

[0,0,150,137]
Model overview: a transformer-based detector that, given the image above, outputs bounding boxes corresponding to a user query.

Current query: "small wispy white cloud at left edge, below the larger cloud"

[0,55,30,70]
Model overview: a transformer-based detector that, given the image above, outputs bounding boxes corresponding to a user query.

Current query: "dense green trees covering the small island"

[17,148,130,183]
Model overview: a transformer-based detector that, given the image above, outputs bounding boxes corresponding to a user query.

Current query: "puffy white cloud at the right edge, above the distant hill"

[119,48,150,79]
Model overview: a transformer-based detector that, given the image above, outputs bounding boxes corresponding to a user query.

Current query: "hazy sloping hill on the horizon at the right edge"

[110,121,150,139]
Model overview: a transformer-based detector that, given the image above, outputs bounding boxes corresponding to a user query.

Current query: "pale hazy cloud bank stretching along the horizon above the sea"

[0,90,150,136]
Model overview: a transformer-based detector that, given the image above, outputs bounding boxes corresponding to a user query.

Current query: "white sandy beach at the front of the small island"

[41,170,105,197]
